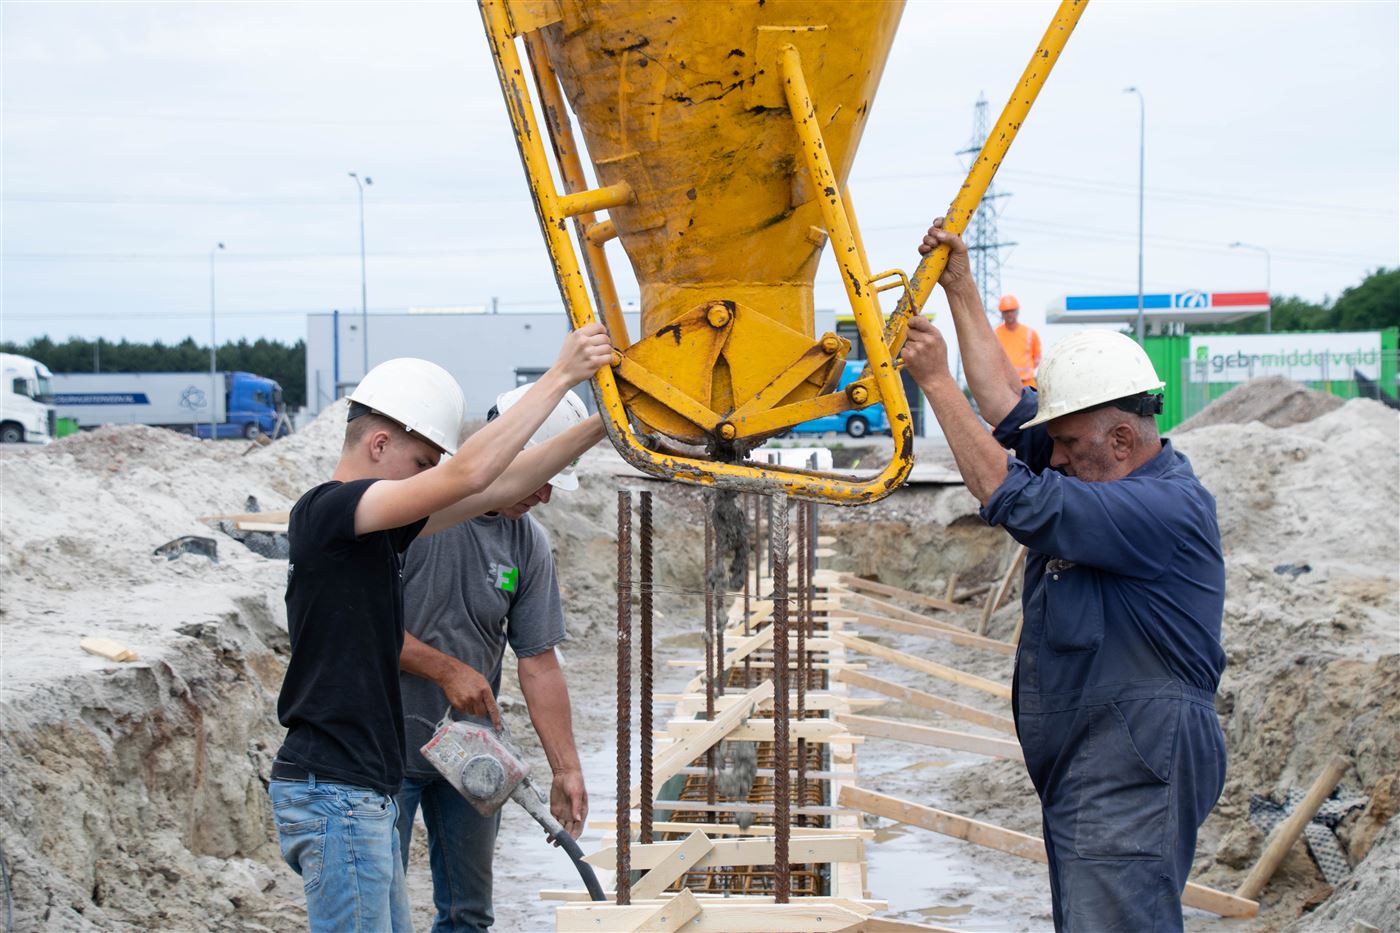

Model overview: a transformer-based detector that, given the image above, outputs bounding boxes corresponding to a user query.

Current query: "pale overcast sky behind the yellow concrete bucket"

[0,0,1400,354]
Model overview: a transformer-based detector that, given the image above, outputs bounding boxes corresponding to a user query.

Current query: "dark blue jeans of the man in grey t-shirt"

[399,778,501,933]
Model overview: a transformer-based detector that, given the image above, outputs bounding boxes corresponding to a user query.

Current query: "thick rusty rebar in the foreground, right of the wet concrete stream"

[769,493,792,904]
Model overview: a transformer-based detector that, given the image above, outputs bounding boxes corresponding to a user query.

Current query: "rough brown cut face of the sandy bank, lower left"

[0,597,298,930]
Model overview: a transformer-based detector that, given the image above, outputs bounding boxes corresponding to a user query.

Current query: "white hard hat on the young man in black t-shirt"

[349,356,466,454]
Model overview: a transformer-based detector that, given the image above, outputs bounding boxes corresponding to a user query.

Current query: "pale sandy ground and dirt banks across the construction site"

[0,381,1400,930]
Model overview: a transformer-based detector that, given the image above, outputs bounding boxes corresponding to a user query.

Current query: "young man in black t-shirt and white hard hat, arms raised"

[269,325,612,932]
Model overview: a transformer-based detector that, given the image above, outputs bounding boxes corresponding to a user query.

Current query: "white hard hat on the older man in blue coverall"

[1021,331,1163,430]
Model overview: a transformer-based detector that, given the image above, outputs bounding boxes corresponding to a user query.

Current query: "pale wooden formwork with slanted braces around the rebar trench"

[546,504,1259,933]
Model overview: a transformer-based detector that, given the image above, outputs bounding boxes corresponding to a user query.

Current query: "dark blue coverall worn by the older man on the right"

[981,388,1225,933]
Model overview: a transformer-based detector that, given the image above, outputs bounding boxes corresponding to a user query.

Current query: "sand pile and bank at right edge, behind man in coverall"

[1176,399,1400,916]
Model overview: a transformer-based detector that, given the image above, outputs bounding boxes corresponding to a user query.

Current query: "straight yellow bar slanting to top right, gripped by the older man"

[867,0,1089,356]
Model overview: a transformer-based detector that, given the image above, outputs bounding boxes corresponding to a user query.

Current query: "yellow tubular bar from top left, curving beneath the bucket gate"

[479,0,913,506]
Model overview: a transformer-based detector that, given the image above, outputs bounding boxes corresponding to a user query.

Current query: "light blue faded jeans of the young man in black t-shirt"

[267,775,413,933]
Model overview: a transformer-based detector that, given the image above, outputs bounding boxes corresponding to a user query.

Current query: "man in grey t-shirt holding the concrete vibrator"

[398,385,588,933]
